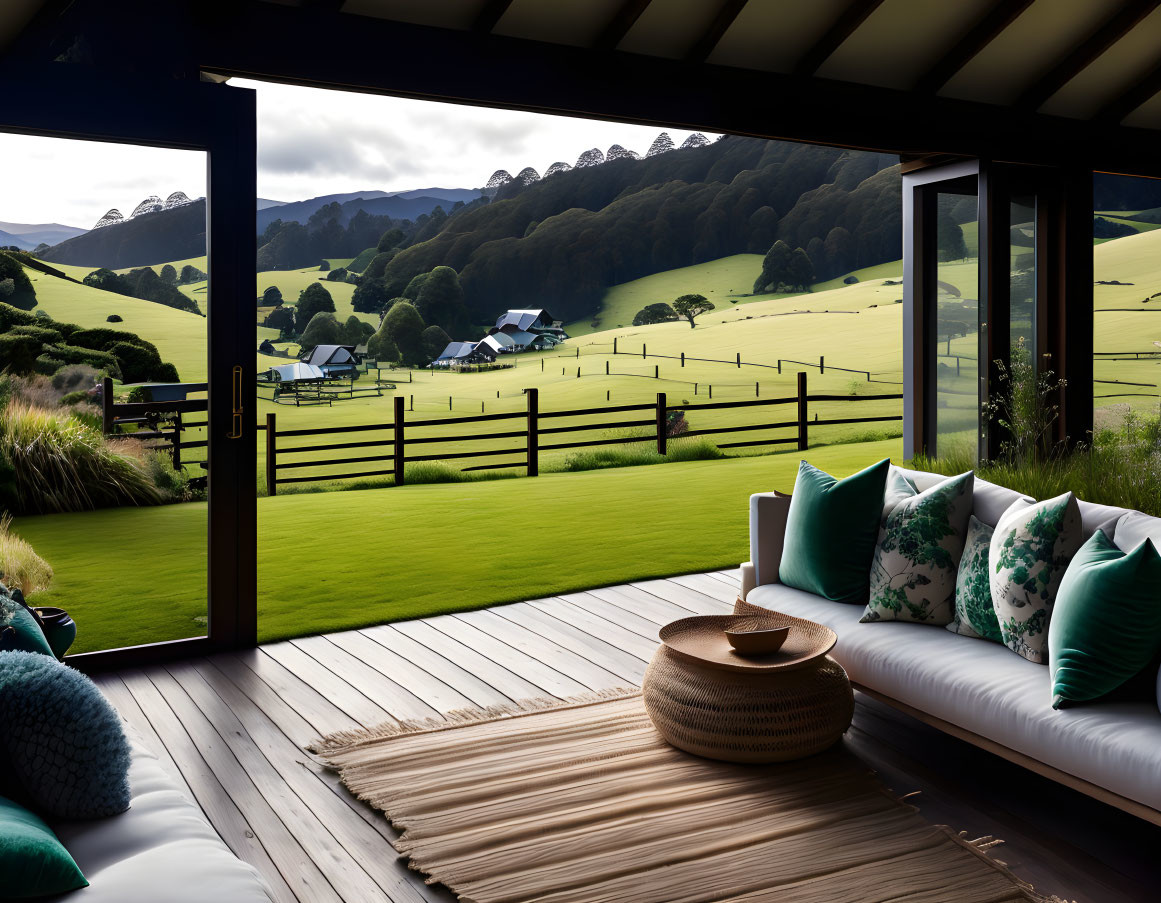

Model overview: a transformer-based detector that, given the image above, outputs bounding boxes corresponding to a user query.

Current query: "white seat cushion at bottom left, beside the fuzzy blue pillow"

[44,743,272,903]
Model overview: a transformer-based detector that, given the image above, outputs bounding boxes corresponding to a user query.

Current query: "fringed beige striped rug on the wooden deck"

[312,691,1063,903]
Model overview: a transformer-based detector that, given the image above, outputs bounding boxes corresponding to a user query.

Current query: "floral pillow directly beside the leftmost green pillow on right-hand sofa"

[859,471,975,626]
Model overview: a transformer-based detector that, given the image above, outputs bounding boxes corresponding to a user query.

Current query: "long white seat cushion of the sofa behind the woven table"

[747,584,1161,810]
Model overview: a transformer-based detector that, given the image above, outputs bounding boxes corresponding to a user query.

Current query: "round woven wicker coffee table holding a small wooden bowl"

[642,611,854,763]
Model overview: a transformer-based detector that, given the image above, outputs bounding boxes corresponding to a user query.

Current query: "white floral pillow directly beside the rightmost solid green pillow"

[988,492,1081,665]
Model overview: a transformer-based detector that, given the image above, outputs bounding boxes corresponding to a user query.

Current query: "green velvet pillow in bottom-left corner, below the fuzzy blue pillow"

[0,796,88,900]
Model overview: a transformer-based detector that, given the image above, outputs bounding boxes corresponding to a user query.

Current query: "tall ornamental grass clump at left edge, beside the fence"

[0,399,166,514]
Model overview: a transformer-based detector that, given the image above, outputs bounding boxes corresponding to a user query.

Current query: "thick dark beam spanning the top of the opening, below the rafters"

[192,0,1161,176]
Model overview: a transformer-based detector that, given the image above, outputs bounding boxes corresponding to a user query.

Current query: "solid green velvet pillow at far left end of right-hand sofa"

[778,458,890,605]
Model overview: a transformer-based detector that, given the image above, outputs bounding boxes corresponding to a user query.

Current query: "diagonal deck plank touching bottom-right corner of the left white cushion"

[121,670,305,903]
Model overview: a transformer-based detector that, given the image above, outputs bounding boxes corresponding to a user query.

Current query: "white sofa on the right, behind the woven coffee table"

[742,470,1161,824]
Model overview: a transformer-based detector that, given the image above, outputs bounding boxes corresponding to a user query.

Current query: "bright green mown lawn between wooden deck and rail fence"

[14,440,901,652]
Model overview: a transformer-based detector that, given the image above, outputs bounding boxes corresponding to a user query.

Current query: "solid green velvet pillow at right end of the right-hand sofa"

[1048,530,1161,709]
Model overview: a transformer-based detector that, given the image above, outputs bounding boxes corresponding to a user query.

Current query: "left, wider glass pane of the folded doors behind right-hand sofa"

[935,192,980,461]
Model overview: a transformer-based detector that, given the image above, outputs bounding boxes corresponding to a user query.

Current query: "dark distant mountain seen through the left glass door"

[43,198,205,269]
